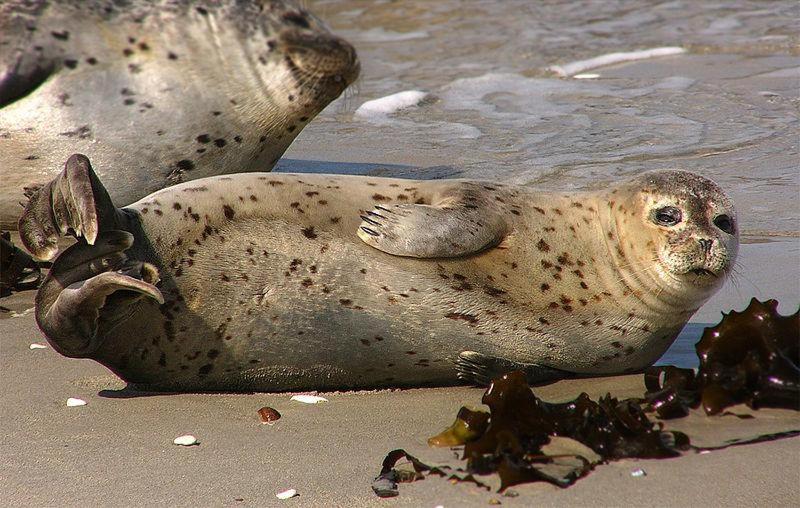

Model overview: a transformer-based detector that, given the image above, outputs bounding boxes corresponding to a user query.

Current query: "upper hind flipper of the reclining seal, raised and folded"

[19,154,126,261]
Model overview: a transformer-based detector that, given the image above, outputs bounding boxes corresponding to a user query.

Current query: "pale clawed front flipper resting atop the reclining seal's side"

[358,183,508,258]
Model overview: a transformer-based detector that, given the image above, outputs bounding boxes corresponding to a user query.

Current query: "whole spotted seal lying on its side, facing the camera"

[20,155,738,391]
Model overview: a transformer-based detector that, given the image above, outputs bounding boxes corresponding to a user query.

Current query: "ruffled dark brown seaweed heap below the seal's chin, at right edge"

[645,298,800,418]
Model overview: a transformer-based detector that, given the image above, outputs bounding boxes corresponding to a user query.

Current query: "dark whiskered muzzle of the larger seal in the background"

[280,30,361,91]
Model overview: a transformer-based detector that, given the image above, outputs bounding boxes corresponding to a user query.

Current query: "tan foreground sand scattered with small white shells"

[0,232,800,507]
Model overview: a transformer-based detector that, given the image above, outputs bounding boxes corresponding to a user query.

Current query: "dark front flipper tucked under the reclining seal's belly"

[456,351,574,386]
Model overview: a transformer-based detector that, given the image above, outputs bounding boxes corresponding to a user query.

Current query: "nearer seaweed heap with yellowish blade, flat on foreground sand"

[373,371,689,496]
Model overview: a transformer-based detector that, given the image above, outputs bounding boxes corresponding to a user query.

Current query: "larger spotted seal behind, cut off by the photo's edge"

[0,0,359,228]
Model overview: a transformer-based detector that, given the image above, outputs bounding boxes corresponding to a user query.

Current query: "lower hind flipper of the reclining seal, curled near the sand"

[36,231,164,358]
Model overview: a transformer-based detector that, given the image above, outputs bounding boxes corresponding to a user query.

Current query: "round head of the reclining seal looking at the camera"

[604,171,739,309]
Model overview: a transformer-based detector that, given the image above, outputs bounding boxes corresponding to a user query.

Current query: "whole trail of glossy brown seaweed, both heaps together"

[373,298,800,497]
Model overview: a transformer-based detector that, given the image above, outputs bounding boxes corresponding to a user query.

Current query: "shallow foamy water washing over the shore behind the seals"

[278,0,800,364]
